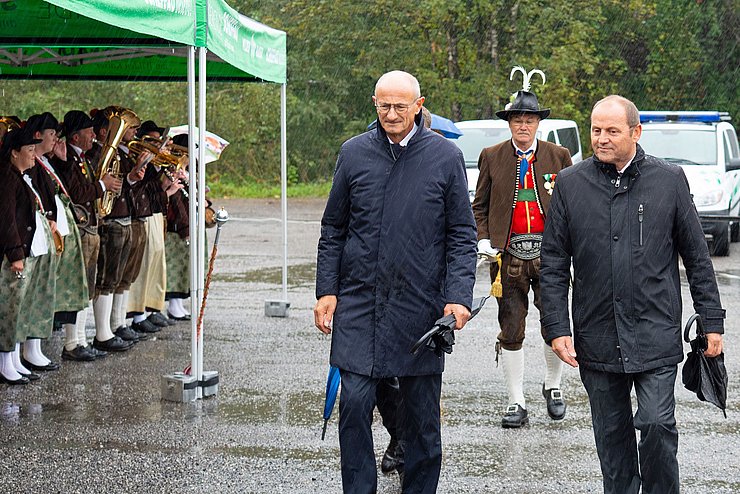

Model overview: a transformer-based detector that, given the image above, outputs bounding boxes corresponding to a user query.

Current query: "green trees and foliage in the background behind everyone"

[0,0,740,197]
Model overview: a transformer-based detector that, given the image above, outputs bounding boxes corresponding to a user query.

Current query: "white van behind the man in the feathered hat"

[452,118,583,202]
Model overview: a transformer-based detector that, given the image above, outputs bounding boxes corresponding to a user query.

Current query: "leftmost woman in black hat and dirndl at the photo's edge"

[0,129,55,384]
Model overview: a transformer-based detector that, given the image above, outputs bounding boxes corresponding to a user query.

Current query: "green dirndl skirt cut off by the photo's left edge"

[0,256,33,352]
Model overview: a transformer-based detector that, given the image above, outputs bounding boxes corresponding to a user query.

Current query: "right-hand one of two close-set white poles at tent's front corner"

[197,47,208,398]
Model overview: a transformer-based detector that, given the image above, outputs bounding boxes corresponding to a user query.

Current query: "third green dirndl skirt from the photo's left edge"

[54,196,88,312]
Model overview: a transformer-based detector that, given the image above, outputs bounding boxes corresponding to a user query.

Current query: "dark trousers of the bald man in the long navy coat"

[339,370,442,494]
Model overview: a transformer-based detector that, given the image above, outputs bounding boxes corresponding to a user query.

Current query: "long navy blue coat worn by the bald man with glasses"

[316,117,476,377]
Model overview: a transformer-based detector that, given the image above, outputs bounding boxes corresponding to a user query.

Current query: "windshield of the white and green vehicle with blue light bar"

[639,126,717,165]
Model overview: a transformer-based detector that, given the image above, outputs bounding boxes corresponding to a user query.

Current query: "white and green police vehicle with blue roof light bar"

[640,111,740,256]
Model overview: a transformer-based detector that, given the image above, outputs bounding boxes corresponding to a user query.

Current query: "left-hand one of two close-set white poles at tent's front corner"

[188,46,199,377]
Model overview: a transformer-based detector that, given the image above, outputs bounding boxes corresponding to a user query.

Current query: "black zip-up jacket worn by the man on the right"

[540,145,725,373]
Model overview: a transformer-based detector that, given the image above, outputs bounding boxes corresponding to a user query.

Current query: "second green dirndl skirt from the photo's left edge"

[16,214,58,341]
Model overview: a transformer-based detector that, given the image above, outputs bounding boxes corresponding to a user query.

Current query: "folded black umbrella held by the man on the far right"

[683,314,727,418]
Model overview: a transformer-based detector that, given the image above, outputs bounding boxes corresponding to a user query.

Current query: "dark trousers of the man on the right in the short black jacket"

[580,365,680,494]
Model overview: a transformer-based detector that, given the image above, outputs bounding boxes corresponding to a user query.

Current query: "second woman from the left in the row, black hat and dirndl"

[24,112,95,361]
